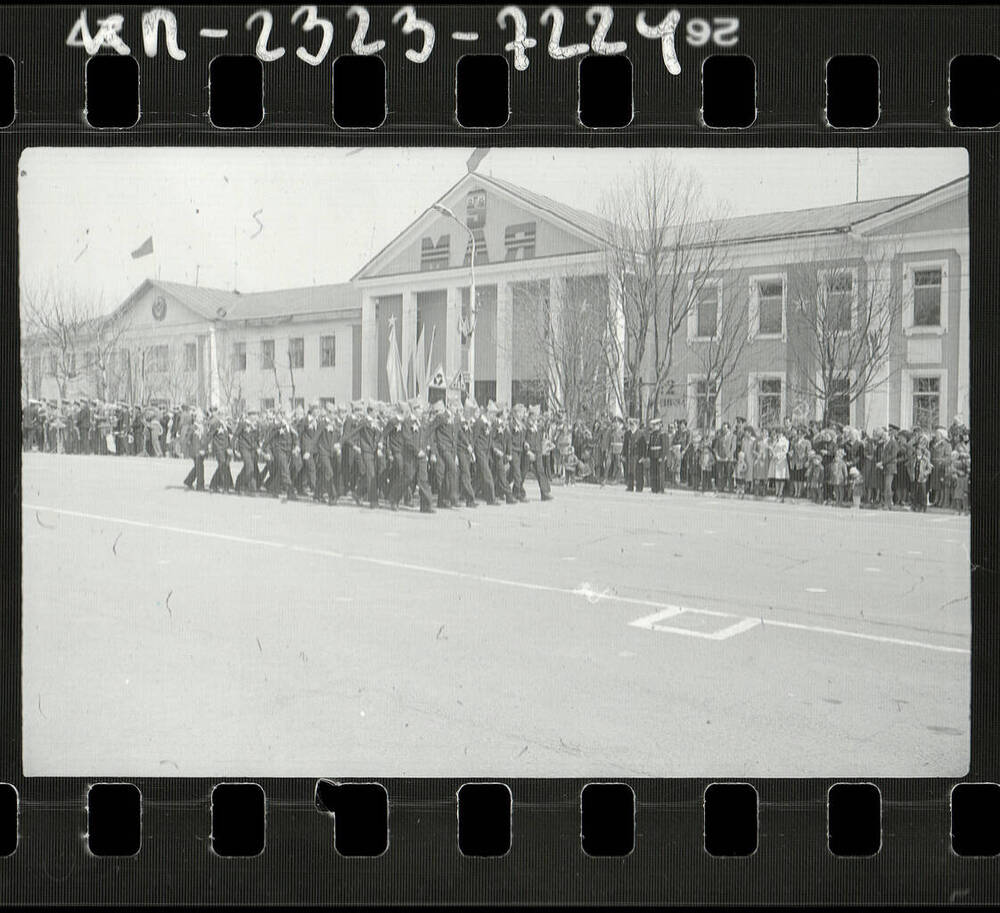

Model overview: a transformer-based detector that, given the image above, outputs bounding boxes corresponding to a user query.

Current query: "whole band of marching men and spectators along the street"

[17,396,971,513]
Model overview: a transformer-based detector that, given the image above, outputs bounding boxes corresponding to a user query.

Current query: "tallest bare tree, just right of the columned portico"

[603,159,728,415]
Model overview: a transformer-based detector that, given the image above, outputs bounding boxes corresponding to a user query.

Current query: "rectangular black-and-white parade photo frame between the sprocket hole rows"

[17,146,972,778]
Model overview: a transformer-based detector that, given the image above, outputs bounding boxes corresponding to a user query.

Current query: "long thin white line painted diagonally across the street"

[27,503,971,654]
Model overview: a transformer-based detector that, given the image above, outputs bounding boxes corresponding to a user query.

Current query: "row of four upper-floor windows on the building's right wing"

[689,267,944,339]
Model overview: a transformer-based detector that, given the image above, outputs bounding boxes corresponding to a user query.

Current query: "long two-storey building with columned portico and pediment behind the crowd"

[22,172,969,427]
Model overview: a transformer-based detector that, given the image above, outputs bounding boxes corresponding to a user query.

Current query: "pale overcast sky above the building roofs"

[18,148,968,310]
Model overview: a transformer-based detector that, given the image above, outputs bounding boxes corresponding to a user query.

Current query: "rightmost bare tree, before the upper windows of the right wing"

[790,237,901,424]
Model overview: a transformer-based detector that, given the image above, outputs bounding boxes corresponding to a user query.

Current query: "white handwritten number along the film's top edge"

[66,5,740,76]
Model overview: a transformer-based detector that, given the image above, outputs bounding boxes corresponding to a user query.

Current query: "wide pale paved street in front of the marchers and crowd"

[22,453,970,777]
